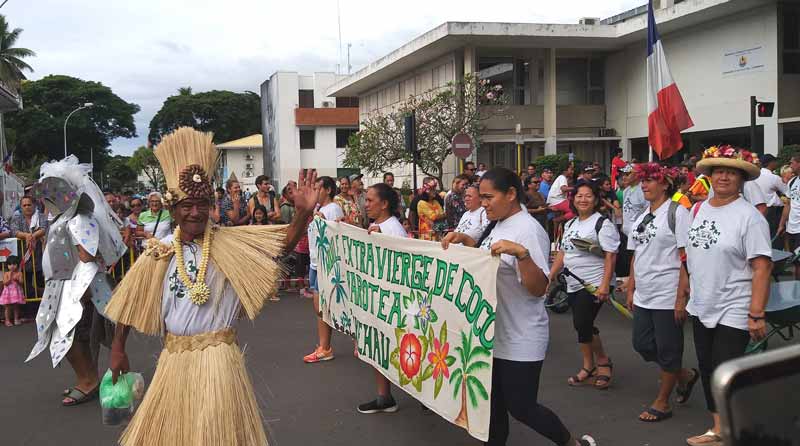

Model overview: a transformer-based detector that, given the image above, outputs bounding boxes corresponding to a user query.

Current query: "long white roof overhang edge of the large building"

[327,0,776,97]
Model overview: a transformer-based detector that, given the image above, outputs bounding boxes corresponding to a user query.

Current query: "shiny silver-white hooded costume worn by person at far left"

[26,155,127,367]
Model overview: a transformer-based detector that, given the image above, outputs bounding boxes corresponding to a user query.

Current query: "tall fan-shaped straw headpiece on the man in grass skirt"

[154,127,218,206]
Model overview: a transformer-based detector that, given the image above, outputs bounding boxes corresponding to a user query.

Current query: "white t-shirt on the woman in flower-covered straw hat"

[686,198,772,330]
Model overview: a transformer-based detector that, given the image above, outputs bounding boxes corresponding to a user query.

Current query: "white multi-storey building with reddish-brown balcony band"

[261,71,358,187]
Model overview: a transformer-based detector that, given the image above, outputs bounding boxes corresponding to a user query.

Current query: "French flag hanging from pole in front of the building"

[647,0,694,160]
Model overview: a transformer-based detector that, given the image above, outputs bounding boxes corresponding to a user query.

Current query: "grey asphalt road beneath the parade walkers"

[0,293,788,446]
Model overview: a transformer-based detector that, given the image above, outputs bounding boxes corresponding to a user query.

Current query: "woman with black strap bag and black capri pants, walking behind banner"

[550,182,619,389]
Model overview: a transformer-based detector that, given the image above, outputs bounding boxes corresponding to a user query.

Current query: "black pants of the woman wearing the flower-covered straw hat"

[691,316,750,413]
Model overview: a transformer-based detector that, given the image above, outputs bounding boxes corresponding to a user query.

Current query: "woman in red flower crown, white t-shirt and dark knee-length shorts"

[627,163,700,423]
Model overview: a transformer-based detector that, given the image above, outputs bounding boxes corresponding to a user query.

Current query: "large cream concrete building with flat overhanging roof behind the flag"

[327,0,800,182]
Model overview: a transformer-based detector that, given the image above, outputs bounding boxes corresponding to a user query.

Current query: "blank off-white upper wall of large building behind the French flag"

[606,5,788,151]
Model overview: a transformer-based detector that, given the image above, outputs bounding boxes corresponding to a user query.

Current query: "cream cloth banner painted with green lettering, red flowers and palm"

[311,218,499,441]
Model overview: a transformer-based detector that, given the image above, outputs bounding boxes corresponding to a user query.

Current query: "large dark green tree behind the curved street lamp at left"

[5,75,139,171]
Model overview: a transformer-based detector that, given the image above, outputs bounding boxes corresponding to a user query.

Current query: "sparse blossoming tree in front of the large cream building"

[344,75,506,184]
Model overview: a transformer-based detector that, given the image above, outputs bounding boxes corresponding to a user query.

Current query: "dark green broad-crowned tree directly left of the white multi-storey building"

[148,87,261,144]
